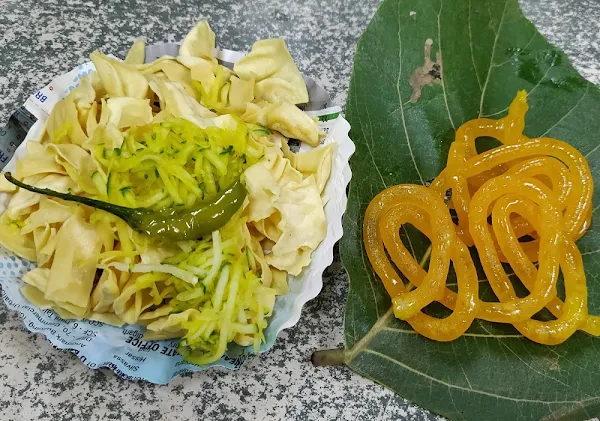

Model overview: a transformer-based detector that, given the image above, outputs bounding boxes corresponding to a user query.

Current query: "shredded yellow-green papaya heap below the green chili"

[154,218,276,364]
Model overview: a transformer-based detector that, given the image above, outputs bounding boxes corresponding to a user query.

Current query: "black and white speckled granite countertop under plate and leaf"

[0,0,600,421]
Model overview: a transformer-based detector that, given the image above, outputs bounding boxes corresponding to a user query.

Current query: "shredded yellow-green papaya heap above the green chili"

[92,118,260,209]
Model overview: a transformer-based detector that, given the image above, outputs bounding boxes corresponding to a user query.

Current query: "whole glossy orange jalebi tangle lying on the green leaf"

[364,91,600,345]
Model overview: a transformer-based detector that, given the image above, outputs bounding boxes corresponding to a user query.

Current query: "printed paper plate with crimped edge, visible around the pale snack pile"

[0,44,354,384]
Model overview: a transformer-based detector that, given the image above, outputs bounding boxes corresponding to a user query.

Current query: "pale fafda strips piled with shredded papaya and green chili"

[0,21,334,364]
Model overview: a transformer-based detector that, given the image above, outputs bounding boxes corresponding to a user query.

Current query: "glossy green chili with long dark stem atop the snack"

[4,172,246,241]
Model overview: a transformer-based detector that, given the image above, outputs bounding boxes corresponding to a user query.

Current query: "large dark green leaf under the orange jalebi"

[340,0,600,421]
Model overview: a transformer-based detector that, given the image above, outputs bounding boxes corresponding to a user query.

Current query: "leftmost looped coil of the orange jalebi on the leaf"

[367,191,479,341]
